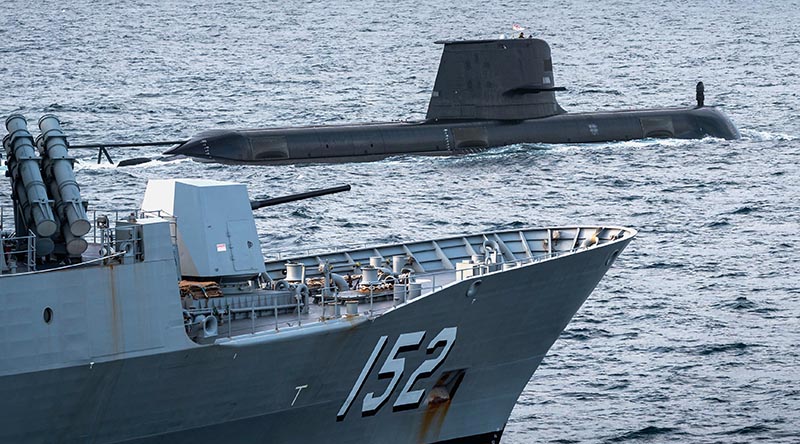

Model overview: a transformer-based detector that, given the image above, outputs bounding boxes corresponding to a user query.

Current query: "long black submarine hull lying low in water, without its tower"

[165,107,739,164]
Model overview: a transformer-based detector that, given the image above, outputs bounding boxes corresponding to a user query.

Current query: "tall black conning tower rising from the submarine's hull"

[426,39,565,120]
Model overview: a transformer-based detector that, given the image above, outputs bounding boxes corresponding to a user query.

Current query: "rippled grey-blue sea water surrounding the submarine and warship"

[0,0,800,444]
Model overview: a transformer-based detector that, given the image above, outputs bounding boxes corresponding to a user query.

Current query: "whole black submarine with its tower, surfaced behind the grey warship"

[164,38,740,164]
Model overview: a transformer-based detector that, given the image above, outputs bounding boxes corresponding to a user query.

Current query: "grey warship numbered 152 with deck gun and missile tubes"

[0,115,636,444]
